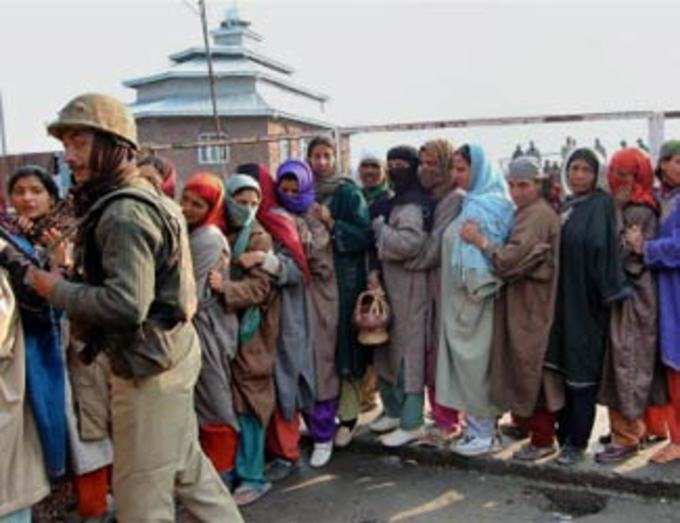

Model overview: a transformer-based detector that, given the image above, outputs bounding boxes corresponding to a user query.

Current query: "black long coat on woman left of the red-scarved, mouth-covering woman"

[546,189,627,385]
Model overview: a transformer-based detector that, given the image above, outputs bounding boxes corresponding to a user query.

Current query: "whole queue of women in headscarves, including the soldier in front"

[0,95,680,523]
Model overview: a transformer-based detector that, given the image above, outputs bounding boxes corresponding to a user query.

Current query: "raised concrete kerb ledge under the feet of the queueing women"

[346,427,680,499]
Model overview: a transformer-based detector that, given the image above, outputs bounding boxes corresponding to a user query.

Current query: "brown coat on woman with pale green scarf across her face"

[222,222,280,426]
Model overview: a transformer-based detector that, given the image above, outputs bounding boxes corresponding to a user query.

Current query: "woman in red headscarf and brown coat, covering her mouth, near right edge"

[595,148,667,463]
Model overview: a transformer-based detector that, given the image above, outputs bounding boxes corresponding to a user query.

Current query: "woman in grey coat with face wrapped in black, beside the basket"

[371,146,431,447]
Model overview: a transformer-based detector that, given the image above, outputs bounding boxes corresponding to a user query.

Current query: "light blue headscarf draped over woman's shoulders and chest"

[451,144,515,271]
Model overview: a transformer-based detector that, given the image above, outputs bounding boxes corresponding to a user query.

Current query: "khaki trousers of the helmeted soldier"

[111,339,243,523]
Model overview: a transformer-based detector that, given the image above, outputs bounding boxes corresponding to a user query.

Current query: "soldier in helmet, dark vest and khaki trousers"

[27,94,242,522]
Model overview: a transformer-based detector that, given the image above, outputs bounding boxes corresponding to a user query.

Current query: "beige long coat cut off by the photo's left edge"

[0,270,50,517]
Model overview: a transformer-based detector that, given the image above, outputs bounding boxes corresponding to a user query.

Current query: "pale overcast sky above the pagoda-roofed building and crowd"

[0,0,680,164]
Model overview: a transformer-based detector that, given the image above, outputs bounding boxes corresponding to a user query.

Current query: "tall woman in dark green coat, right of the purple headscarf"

[307,137,371,467]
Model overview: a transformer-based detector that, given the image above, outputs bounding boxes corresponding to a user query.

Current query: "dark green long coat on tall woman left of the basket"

[328,180,372,378]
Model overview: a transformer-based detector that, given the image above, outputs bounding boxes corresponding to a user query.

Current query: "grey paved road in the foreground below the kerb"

[243,451,680,523]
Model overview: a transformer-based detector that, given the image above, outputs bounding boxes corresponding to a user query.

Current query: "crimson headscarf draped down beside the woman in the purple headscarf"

[257,165,310,281]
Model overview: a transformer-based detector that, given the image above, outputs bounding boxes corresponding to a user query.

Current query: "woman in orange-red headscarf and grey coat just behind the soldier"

[180,172,238,486]
